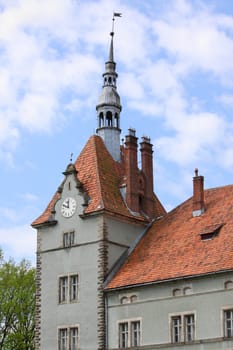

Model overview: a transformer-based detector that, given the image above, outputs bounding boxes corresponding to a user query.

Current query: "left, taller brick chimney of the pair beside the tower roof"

[125,129,139,212]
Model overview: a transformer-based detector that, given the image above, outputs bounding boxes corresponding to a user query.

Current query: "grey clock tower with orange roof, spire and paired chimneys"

[32,23,165,350]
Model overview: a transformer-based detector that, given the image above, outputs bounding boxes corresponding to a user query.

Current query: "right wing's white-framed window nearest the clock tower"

[117,318,142,349]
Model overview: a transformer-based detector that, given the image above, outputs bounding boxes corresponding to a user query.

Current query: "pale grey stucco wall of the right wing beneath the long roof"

[107,274,233,350]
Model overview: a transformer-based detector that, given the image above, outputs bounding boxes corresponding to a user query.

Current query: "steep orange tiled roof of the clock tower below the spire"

[32,135,165,226]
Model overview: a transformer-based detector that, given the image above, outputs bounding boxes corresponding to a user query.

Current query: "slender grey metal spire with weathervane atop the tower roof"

[96,12,122,161]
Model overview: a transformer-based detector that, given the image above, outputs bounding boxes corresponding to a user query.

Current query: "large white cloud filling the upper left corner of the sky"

[0,0,104,146]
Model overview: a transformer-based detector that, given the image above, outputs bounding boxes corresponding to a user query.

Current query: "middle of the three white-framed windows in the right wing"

[169,311,196,344]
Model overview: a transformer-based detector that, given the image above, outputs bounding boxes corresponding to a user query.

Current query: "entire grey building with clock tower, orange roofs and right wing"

[32,32,233,350]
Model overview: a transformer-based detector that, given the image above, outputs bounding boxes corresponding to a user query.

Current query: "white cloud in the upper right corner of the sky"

[153,1,233,80]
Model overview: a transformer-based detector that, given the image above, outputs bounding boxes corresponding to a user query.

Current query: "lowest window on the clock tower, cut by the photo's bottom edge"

[58,327,79,350]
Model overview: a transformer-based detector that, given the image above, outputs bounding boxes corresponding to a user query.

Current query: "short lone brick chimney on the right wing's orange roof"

[193,169,205,216]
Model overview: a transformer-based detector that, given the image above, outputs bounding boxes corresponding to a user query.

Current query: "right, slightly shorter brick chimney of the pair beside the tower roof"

[140,136,154,217]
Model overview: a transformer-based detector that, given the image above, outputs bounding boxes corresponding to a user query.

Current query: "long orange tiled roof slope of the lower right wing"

[107,185,233,289]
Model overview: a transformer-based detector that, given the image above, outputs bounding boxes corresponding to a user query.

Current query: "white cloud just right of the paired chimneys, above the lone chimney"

[157,113,225,166]
